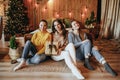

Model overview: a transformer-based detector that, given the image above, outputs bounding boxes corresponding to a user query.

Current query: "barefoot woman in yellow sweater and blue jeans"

[14,20,51,71]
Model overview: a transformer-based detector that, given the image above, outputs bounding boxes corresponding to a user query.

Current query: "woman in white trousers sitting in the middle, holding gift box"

[51,19,84,79]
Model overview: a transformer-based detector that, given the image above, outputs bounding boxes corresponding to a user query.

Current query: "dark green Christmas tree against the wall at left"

[4,0,29,35]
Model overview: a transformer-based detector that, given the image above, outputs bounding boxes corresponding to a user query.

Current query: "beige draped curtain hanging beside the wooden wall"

[100,0,120,39]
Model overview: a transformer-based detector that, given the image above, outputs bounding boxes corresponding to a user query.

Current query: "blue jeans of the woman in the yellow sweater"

[22,40,46,64]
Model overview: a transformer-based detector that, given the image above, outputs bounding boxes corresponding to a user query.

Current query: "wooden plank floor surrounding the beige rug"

[0,34,120,80]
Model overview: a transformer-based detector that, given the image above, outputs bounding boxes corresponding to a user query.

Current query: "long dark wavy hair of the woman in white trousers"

[52,19,67,38]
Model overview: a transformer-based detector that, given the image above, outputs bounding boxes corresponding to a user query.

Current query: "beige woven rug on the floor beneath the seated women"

[11,60,71,72]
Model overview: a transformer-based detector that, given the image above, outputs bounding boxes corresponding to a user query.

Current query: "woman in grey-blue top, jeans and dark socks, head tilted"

[68,20,117,76]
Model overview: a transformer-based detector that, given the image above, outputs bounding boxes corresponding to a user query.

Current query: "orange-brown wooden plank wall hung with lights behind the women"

[24,0,98,26]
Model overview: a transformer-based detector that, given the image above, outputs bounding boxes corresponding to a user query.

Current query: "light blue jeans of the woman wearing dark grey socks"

[76,40,104,63]
